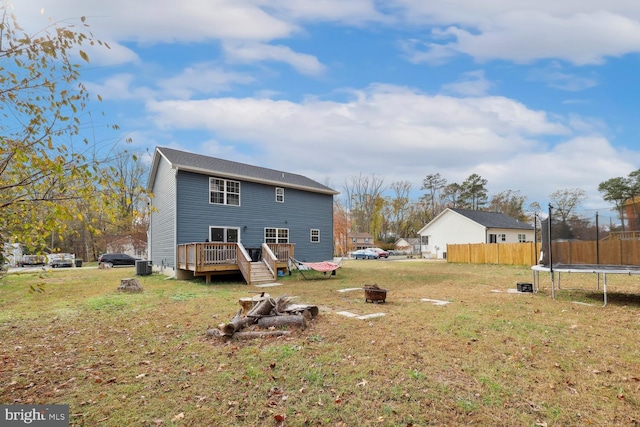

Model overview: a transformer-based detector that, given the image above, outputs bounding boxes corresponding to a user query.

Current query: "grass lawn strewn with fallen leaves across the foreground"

[0,260,640,427]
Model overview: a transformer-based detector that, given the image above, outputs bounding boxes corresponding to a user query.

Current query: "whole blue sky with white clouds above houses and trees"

[15,0,640,211]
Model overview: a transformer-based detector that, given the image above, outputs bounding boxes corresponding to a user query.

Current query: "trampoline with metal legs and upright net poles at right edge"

[531,205,640,307]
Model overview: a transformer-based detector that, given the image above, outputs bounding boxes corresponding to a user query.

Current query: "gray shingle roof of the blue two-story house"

[151,147,338,194]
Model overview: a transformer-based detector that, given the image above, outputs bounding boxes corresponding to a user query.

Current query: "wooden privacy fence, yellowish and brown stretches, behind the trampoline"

[447,240,640,265]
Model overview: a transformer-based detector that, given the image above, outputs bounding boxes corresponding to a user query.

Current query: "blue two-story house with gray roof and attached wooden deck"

[148,147,338,284]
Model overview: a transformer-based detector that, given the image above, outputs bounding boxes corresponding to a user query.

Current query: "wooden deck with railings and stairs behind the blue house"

[177,242,294,285]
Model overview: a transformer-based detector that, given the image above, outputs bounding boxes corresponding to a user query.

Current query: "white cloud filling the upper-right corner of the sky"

[398,0,640,65]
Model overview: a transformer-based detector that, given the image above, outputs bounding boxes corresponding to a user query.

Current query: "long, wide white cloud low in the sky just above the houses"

[147,86,600,202]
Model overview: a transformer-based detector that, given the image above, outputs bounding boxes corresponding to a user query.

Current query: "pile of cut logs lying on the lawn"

[207,292,318,340]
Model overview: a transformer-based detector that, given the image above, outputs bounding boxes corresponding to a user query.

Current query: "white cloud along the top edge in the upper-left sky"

[16,0,298,43]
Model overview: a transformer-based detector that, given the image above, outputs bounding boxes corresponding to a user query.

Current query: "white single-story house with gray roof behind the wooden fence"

[418,208,534,259]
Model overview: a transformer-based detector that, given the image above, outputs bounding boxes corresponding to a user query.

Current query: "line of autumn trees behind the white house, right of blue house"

[334,173,600,254]
